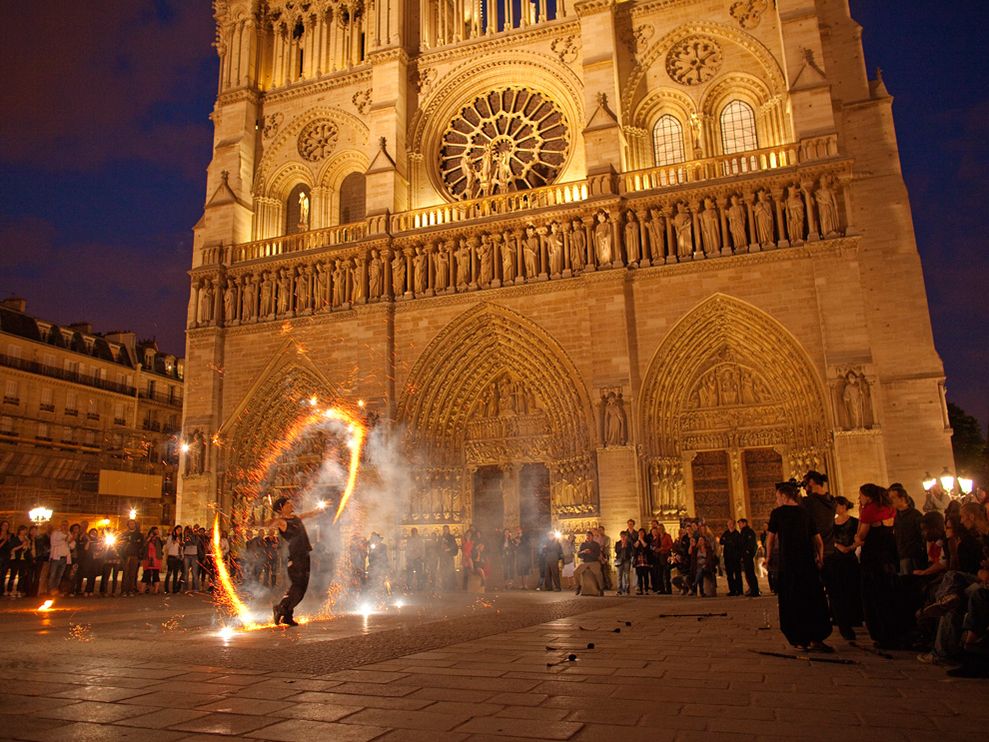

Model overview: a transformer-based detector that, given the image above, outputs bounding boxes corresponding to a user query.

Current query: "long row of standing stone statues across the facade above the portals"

[193,175,841,325]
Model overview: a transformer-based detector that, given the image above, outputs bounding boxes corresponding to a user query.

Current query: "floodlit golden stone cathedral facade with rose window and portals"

[179,0,952,534]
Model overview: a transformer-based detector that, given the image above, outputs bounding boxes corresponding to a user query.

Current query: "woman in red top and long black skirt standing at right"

[835,484,908,648]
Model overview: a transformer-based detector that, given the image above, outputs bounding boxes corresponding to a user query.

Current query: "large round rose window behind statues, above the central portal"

[439,88,570,199]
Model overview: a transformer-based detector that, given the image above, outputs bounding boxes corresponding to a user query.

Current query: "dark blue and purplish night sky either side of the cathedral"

[0,0,989,424]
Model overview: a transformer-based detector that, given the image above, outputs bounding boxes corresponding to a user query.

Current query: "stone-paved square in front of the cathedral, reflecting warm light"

[0,593,989,742]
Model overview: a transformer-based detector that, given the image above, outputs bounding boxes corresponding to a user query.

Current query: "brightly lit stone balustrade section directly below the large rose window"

[390,180,587,234]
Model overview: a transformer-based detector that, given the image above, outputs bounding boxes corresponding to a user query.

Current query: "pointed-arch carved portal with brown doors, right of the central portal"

[639,294,829,520]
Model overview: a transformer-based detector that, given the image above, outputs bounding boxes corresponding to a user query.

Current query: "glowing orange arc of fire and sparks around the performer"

[213,398,367,630]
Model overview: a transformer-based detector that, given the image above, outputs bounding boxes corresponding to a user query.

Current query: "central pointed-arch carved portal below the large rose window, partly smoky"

[398,304,598,528]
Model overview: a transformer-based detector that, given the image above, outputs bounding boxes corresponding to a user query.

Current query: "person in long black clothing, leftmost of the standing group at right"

[766,482,834,652]
